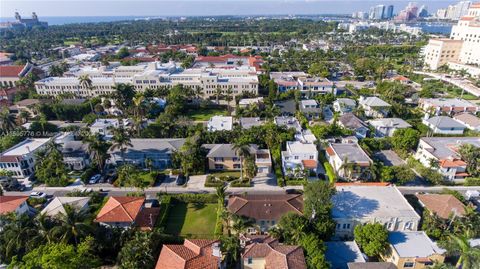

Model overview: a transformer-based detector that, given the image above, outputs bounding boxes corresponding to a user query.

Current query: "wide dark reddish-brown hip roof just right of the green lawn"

[228,194,303,220]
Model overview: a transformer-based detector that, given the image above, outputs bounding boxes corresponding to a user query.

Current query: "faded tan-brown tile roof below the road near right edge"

[417,194,465,219]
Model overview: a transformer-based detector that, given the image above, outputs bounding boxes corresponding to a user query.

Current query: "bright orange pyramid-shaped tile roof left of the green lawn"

[95,196,145,223]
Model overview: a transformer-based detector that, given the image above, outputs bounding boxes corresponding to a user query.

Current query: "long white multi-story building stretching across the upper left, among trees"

[35,63,258,98]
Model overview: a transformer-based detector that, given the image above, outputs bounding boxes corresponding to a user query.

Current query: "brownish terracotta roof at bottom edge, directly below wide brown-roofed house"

[242,236,307,269]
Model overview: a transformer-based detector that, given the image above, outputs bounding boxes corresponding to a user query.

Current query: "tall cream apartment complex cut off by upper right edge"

[425,3,480,75]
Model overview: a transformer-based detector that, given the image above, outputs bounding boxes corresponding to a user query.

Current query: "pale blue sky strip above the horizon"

[0,0,457,18]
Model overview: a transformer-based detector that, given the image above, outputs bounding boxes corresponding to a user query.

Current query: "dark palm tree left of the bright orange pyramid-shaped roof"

[52,205,91,245]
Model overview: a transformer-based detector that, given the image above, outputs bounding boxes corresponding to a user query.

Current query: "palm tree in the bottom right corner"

[449,235,480,269]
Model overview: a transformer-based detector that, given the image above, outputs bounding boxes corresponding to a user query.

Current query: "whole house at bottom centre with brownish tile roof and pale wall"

[241,235,307,269]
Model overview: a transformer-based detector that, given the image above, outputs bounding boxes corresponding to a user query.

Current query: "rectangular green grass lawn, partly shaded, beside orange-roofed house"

[166,203,217,239]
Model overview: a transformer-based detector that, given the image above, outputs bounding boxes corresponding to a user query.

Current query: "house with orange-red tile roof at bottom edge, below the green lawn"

[155,239,222,269]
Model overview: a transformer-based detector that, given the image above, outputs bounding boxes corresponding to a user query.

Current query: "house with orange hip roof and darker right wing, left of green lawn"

[94,196,158,230]
